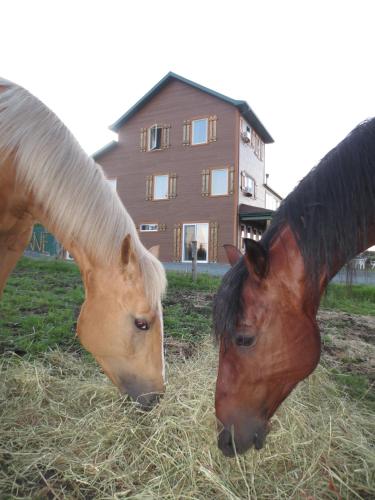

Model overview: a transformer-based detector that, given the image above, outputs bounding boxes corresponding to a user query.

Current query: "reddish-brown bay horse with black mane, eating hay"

[214,119,375,456]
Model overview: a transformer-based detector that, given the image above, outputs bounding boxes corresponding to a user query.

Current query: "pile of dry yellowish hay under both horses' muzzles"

[0,343,375,500]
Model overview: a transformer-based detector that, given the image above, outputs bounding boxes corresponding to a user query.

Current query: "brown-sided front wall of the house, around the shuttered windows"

[96,81,238,262]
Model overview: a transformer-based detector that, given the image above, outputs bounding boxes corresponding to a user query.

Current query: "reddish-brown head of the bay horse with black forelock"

[214,235,320,456]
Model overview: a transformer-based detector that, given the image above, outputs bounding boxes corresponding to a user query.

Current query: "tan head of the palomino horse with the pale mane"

[74,235,165,409]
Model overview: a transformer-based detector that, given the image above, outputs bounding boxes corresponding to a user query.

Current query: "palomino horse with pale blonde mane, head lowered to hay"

[0,79,166,408]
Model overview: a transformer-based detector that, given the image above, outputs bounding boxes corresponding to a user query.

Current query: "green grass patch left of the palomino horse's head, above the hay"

[0,258,84,354]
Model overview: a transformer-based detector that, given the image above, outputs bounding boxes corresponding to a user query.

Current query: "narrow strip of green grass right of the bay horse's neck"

[321,284,375,316]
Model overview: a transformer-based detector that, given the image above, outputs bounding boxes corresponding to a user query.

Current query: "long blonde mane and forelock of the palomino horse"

[0,78,166,306]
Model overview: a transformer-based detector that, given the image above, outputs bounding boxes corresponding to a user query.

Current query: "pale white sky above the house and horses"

[0,0,375,198]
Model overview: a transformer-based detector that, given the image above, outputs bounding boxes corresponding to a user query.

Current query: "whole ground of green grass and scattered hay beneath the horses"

[0,258,375,499]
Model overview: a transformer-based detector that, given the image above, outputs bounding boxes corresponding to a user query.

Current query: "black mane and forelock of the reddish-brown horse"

[214,118,375,337]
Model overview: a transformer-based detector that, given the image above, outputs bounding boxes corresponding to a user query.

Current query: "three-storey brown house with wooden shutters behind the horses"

[93,73,281,262]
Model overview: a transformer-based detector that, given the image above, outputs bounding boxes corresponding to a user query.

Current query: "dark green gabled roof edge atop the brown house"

[109,71,274,144]
